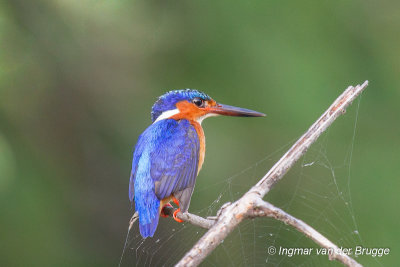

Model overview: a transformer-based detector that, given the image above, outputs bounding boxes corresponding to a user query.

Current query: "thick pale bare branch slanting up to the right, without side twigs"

[177,81,368,266]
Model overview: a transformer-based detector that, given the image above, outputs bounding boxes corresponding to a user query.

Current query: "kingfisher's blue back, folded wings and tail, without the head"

[129,119,200,237]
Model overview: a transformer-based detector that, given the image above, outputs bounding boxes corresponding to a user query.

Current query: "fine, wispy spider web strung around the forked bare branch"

[121,101,381,266]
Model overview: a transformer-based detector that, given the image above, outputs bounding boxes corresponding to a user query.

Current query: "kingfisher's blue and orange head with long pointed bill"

[151,89,265,123]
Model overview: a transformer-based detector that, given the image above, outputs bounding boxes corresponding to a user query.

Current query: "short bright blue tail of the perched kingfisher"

[135,191,160,238]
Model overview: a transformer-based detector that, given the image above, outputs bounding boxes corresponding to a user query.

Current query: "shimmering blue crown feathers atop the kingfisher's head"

[151,89,211,122]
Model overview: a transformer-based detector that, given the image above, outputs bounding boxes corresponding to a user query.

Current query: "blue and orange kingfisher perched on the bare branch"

[129,89,265,238]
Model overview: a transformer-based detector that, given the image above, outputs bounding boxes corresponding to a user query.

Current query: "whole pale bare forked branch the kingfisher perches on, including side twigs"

[176,81,368,266]
